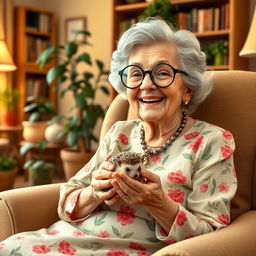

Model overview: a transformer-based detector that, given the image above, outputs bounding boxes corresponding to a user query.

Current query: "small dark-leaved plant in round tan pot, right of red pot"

[22,96,55,142]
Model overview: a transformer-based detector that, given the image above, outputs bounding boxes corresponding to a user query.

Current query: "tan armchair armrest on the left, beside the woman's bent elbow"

[0,184,60,241]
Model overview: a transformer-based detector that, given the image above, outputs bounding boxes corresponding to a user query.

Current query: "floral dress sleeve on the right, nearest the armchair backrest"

[156,130,237,244]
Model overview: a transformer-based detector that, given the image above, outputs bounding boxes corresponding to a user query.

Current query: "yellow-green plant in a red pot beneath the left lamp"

[0,87,19,126]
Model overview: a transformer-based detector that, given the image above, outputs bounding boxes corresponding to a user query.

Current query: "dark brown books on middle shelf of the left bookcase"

[25,36,51,62]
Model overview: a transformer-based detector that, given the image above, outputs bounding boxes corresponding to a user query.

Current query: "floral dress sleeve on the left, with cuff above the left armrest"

[58,122,115,222]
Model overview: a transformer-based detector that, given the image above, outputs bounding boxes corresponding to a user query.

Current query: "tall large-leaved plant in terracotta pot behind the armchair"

[37,30,109,179]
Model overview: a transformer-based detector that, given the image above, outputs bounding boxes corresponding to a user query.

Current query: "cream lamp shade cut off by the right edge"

[239,7,256,57]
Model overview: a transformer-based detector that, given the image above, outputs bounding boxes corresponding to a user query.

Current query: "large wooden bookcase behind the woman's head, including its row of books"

[112,0,250,91]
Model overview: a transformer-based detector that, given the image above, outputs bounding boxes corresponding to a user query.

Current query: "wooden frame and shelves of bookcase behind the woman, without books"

[113,0,249,70]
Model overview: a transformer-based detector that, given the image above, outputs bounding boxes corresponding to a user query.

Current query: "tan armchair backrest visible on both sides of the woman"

[100,71,256,219]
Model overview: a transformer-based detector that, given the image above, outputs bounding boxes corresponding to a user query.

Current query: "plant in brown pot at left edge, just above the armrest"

[0,155,18,191]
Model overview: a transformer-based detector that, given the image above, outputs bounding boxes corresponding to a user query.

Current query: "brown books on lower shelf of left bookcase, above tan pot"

[26,77,49,98]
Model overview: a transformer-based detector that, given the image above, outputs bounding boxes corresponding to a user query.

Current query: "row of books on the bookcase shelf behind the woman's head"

[177,3,230,33]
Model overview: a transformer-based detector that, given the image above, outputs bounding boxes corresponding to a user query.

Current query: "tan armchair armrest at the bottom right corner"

[152,211,256,256]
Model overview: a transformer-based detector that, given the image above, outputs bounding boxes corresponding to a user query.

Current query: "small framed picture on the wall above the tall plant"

[65,17,86,42]
